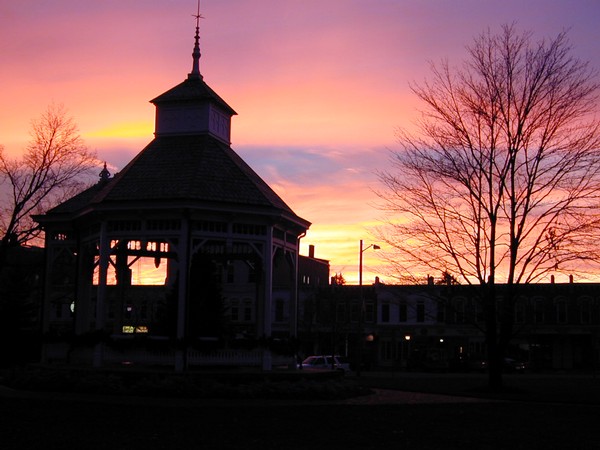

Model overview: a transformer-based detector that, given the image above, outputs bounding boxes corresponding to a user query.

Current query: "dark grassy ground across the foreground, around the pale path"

[0,374,600,450]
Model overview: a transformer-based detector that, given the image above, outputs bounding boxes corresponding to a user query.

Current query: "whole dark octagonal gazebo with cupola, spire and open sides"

[35,17,310,371]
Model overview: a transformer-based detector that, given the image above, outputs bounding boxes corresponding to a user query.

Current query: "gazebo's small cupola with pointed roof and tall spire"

[151,15,236,144]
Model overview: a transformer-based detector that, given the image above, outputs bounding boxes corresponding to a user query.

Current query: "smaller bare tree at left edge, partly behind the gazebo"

[0,105,97,267]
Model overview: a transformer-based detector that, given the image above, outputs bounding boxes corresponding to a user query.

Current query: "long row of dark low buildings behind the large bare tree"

[300,279,600,371]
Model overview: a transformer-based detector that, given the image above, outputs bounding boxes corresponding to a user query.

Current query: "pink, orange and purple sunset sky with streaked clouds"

[0,0,600,283]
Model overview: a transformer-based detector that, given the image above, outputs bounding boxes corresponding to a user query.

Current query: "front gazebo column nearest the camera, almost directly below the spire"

[175,217,190,372]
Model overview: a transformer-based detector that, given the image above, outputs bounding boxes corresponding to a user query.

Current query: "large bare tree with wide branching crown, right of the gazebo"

[378,25,600,388]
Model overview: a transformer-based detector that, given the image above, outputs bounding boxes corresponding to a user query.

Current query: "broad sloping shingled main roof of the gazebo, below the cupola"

[48,134,303,225]
